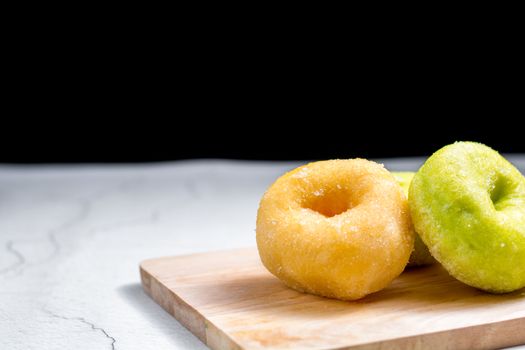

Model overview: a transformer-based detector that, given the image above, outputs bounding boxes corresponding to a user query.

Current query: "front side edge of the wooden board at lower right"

[346,318,525,350]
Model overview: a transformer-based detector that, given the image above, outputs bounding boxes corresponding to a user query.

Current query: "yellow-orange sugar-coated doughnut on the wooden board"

[256,159,414,300]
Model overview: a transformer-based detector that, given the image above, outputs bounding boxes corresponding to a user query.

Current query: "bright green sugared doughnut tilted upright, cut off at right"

[409,142,525,293]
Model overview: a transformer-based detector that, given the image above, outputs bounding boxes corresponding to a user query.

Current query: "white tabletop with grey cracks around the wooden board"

[0,159,525,350]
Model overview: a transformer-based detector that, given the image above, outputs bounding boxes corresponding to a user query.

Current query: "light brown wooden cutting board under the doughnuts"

[140,248,525,349]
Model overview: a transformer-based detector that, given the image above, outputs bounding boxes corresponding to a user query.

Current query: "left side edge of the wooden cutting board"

[139,259,242,350]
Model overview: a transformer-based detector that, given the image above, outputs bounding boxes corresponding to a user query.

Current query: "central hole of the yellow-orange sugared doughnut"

[302,188,354,218]
